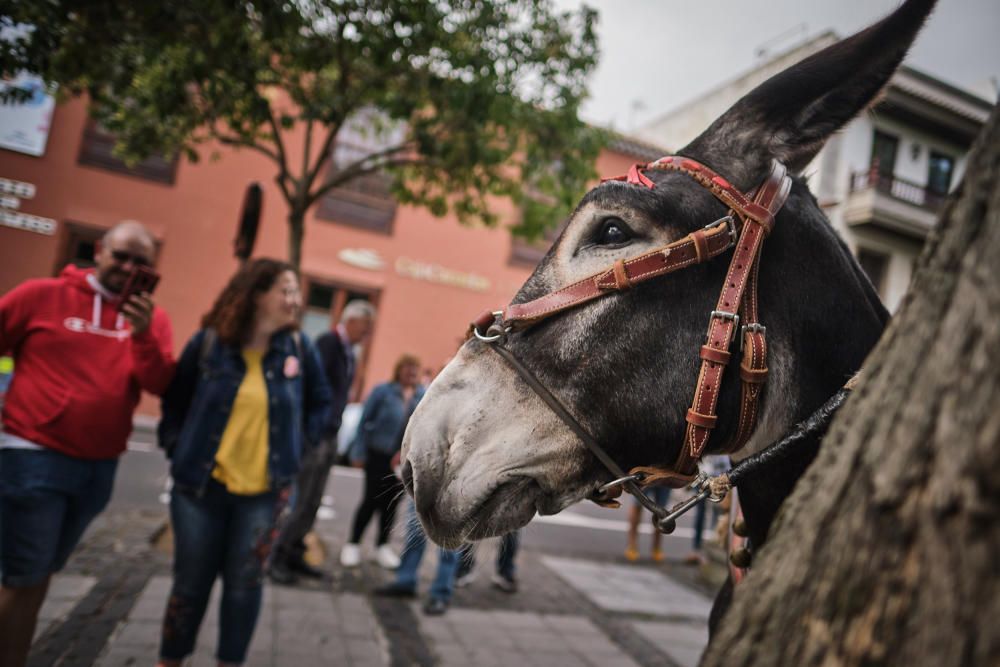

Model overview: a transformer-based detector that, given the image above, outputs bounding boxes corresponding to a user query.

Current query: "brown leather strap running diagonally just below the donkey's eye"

[503,218,733,329]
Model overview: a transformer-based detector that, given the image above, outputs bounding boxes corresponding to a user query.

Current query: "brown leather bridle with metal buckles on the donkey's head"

[472,155,792,533]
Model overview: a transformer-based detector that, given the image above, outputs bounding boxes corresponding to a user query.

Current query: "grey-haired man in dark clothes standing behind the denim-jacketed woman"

[269,299,375,584]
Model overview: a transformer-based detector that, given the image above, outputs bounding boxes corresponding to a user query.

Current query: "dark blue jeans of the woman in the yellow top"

[160,480,288,663]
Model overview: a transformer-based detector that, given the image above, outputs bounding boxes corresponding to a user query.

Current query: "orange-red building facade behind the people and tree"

[0,100,659,414]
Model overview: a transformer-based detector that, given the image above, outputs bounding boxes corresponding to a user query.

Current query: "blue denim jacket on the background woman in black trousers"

[348,382,424,461]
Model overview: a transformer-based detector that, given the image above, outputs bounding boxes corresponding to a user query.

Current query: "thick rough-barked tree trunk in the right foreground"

[702,109,1000,667]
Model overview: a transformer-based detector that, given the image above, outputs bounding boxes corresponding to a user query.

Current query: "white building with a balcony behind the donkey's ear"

[635,32,993,310]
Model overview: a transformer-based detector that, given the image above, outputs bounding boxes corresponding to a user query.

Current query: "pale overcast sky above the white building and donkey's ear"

[556,0,1000,132]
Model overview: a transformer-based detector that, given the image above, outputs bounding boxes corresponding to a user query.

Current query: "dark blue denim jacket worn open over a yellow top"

[158,330,330,493]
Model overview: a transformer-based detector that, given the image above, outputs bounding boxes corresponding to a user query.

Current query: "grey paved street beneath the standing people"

[29,436,728,667]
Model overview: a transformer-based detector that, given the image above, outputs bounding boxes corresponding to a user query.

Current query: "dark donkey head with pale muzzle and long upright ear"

[403,1,933,546]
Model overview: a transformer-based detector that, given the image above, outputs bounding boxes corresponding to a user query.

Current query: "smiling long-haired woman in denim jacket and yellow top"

[159,259,330,667]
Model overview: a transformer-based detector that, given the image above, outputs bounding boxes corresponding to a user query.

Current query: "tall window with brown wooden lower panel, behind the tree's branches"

[316,109,405,234]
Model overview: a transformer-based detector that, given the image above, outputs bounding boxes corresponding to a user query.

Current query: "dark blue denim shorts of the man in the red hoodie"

[0,449,118,588]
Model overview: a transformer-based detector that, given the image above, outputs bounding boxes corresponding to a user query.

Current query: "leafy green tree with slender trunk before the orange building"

[0,0,602,266]
